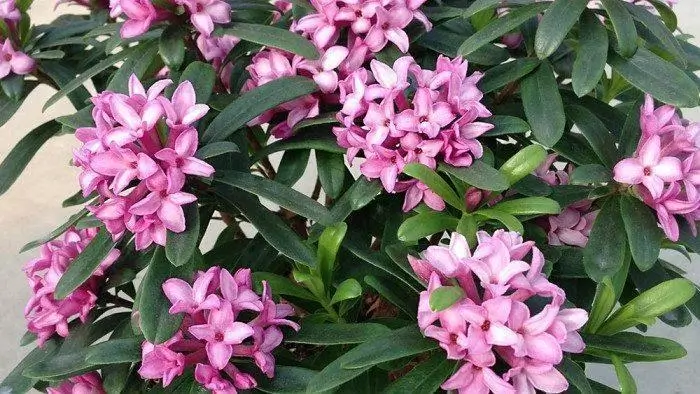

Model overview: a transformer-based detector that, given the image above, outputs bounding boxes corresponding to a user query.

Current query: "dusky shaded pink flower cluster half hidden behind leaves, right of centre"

[535,154,600,247]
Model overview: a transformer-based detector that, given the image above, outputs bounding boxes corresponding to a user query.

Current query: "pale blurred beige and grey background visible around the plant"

[0,0,700,393]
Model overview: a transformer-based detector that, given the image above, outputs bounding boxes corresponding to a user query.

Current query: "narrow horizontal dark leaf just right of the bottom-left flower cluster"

[284,322,391,346]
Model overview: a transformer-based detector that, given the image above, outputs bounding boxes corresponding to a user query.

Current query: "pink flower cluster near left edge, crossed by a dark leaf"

[23,228,120,345]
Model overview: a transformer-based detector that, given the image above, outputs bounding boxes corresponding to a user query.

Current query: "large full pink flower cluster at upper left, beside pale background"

[73,75,214,250]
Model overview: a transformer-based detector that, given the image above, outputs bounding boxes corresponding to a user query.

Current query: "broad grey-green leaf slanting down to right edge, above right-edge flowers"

[609,48,700,108]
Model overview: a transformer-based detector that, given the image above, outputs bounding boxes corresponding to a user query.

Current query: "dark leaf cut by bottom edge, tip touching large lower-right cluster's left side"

[383,352,457,394]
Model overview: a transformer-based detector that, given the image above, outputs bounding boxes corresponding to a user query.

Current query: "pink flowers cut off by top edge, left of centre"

[109,0,231,38]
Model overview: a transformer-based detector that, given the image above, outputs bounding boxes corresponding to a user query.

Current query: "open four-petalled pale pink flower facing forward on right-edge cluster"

[614,135,683,198]
